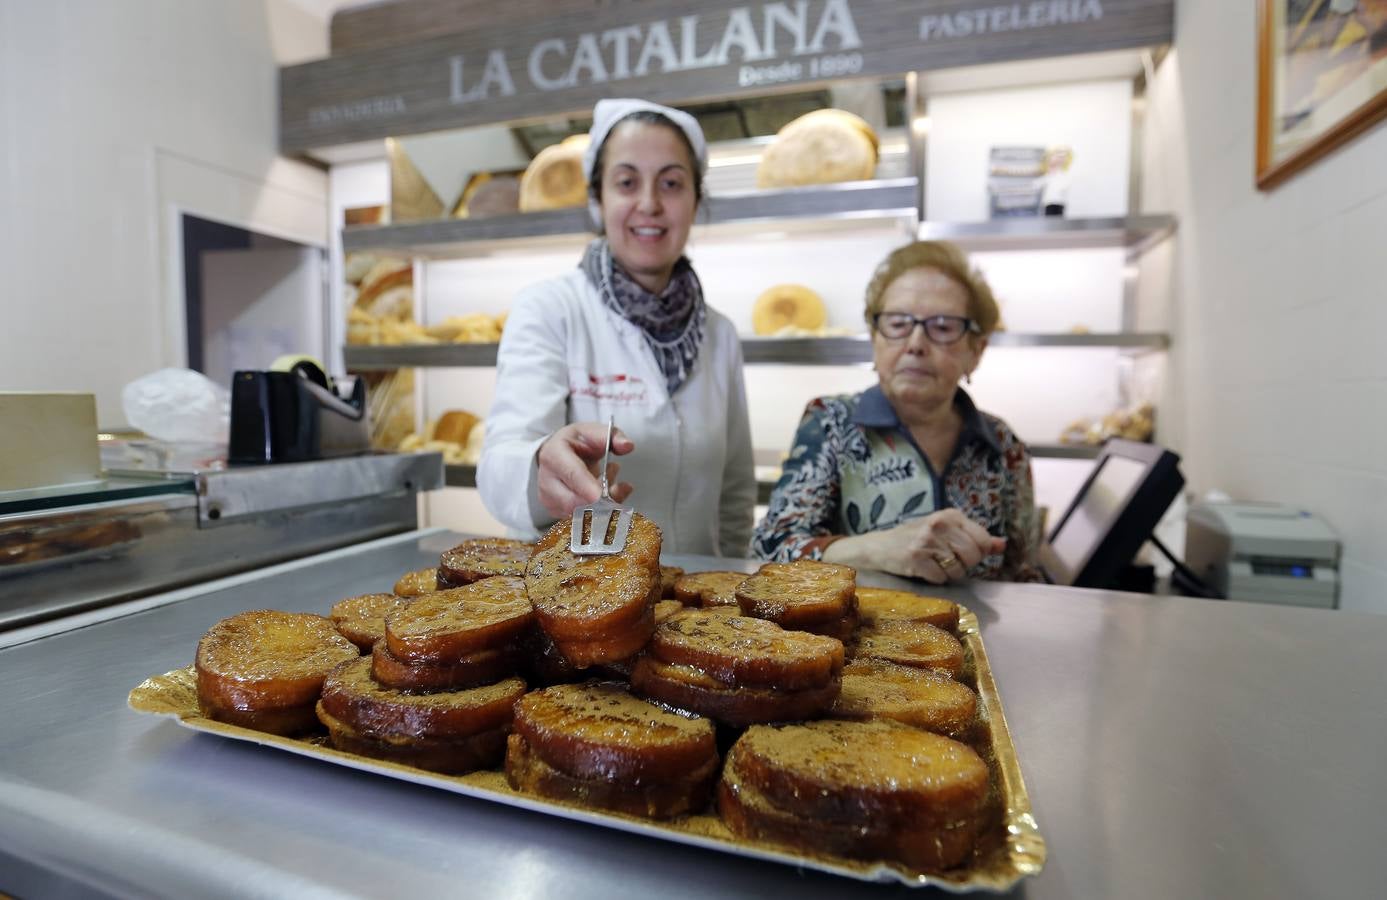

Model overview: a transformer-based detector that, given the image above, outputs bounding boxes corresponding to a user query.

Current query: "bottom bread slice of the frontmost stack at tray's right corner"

[717,767,979,871]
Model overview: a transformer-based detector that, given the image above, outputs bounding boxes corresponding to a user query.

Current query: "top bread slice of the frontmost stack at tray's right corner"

[727,720,988,827]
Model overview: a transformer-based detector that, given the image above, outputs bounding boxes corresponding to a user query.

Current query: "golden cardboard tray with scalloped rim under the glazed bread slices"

[129,607,1046,893]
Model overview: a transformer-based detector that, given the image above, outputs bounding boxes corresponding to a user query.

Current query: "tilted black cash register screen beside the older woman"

[1040,440,1184,588]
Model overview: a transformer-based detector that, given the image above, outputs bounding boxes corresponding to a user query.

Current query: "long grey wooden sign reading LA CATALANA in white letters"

[280,0,1175,151]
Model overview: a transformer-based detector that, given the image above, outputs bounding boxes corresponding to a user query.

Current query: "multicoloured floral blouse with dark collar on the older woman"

[752,386,1043,581]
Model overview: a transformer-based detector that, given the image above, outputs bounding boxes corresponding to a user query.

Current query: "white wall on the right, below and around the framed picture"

[1143,0,1387,613]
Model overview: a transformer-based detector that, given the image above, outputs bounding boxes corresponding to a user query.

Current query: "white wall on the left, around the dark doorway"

[0,0,327,427]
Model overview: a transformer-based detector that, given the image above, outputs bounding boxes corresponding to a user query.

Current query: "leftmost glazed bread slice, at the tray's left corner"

[194,609,361,734]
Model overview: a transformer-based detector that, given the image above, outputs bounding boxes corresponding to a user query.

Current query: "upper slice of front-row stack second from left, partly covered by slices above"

[322,657,526,741]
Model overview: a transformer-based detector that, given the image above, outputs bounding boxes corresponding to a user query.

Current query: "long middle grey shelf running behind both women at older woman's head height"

[343,331,1171,372]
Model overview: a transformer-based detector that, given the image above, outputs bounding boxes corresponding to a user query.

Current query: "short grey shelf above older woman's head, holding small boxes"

[918,215,1175,258]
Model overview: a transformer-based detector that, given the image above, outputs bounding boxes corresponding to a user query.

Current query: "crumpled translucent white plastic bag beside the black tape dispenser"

[121,369,232,444]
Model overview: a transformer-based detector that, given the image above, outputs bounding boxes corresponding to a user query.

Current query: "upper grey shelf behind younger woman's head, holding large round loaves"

[343,178,918,259]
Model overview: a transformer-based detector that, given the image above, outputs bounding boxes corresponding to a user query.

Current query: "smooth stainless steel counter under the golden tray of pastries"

[0,534,1387,900]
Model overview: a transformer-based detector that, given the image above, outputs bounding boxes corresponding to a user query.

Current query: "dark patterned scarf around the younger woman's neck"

[578,237,707,395]
